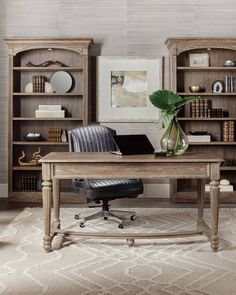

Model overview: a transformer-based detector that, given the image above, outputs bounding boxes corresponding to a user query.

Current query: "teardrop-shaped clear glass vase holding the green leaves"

[160,117,188,156]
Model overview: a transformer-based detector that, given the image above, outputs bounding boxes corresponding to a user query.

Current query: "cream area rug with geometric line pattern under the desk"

[0,208,236,295]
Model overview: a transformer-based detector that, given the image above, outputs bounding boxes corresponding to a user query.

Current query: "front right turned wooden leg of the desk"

[210,180,219,251]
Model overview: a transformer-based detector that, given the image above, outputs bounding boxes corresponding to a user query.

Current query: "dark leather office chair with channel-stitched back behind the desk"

[68,125,143,228]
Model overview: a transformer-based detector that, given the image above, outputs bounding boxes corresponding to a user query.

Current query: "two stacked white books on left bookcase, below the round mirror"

[35,104,65,118]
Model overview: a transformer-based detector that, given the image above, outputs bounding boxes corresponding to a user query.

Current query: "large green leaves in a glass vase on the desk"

[149,90,199,155]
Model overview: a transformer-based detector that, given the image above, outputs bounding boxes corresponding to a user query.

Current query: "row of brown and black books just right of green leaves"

[190,98,223,118]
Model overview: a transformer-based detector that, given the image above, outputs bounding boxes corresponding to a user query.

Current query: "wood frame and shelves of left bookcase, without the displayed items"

[5,37,93,203]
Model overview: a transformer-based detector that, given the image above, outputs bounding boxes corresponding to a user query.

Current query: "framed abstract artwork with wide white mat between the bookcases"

[97,56,162,122]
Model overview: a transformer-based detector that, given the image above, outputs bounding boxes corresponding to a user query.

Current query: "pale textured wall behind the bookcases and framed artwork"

[0,0,236,199]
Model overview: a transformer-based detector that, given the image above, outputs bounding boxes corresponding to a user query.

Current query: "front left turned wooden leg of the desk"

[42,180,52,252]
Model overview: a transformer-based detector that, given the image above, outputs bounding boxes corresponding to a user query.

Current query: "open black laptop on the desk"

[112,134,155,155]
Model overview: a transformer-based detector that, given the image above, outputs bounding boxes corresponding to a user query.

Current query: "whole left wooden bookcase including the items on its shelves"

[5,38,93,203]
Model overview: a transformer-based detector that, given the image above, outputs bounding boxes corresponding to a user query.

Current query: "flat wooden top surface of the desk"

[39,152,223,163]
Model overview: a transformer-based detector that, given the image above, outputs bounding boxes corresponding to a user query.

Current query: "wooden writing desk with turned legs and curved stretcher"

[40,152,222,252]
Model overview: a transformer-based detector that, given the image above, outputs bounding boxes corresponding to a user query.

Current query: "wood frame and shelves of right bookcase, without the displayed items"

[165,37,236,203]
